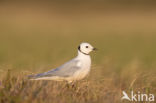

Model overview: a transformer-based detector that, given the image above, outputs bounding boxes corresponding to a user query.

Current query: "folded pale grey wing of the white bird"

[35,60,81,78]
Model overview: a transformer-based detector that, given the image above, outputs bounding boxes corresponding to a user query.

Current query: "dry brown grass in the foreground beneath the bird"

[0,64,156,103]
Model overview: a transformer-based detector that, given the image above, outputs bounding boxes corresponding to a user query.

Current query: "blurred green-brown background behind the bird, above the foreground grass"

[0,0,156,80]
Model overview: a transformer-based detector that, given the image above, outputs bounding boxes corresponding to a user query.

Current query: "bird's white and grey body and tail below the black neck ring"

[29,50,91,81]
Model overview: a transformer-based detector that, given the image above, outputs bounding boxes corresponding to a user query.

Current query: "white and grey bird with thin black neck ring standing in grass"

[30,42,97,83]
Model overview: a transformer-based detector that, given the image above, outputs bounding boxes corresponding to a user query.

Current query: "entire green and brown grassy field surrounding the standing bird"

[0,2,156,103]
